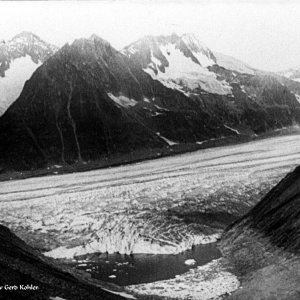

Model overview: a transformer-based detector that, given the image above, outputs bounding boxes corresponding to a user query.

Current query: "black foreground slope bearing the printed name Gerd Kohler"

[0,225,124,300]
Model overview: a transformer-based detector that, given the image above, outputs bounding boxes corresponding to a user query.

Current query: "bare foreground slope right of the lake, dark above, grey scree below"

[220,166,300,299]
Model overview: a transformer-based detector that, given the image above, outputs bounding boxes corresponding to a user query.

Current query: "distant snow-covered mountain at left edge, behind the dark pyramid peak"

[0,32,57,116]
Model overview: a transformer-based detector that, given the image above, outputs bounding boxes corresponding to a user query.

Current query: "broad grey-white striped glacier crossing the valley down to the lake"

[0,135,300,258]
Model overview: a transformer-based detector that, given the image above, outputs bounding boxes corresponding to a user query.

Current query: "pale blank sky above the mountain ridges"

[0,0,300,71]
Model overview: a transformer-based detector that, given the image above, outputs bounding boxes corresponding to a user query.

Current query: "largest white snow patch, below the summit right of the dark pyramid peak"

[144,43,231,95]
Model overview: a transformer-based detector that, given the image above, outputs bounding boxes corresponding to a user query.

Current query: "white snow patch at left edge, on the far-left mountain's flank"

[0,55,41,116]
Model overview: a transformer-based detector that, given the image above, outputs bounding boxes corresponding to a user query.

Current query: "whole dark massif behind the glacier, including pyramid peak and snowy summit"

[0,34,300,170]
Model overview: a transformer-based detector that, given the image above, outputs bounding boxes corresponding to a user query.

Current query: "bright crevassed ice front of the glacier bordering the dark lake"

[44,207,219,258]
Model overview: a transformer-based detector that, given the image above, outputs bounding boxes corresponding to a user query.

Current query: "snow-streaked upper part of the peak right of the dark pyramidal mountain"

[122,34,231,95]
